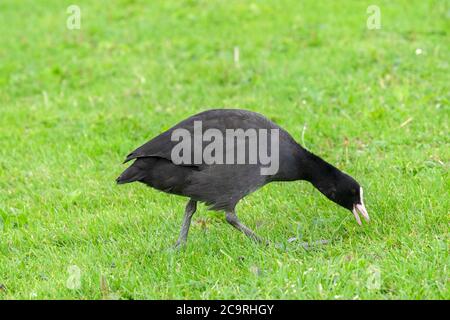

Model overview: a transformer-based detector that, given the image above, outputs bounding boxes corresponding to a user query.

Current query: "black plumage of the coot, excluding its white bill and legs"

[117,109,370,245]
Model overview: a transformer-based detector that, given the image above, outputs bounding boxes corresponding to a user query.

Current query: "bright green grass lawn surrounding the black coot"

[0,0,450,299]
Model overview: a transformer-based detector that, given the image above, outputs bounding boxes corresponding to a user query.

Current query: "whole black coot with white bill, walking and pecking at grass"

[117,109,369,246]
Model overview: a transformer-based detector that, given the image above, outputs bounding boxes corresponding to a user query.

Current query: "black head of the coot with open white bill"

[319,172,370,225]
